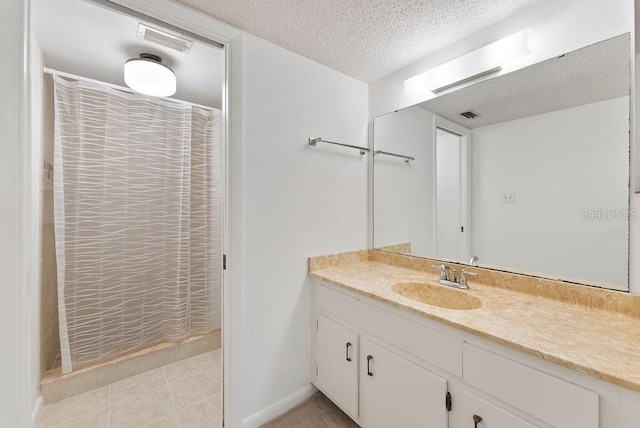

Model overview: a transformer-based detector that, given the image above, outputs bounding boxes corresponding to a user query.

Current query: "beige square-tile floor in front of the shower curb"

[37,349,222,428]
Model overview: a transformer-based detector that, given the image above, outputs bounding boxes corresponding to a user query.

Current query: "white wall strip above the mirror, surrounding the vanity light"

[369,0,634,118]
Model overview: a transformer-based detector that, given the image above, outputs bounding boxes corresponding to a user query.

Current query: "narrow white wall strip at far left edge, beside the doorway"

[0,0,29,427]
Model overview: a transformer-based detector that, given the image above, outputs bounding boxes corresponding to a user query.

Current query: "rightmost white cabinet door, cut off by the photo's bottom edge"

[460,391,536,428]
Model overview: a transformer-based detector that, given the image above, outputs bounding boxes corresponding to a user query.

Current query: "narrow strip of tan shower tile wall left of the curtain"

[40,74,60,377]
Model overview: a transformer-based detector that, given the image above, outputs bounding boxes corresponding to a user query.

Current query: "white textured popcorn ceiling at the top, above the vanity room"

[172,0,542,83]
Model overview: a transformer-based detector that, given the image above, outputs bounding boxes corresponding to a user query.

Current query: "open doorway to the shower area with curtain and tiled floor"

[31,0,226,426]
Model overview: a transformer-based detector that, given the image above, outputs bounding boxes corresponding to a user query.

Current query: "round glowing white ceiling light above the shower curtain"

[124,53,176,97]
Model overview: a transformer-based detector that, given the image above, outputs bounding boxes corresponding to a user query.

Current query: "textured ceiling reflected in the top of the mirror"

[420,34,631,128]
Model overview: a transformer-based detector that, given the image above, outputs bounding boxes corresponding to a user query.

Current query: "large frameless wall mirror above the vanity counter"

[374,34,635,290]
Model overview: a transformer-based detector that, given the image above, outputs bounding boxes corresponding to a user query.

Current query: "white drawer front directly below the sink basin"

[358,302,463,377]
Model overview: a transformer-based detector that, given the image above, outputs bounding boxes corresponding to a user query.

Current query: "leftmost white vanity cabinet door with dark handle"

[316,314,358,419]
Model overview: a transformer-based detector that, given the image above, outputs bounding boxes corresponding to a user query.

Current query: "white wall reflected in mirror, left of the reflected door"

[373,107,435,255]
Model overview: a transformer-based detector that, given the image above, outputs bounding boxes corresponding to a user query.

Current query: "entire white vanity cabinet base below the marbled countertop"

[312,282,604,428]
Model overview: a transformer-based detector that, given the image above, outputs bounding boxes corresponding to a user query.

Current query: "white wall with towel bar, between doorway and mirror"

[235,35,370,426]
